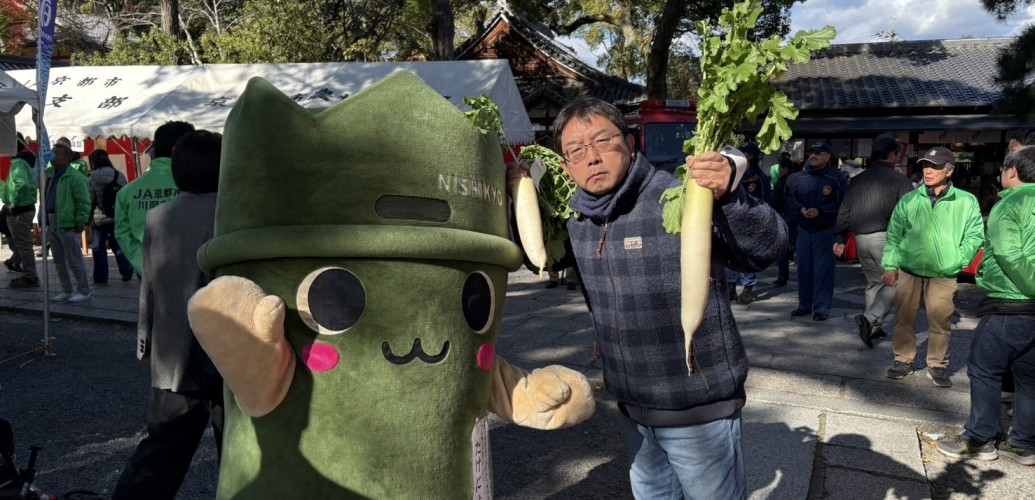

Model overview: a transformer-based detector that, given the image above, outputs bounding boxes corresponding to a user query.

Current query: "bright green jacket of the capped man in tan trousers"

[881,185,984,277]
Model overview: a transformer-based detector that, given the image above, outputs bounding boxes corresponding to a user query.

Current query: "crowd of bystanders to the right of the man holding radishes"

[741,130,1035,472]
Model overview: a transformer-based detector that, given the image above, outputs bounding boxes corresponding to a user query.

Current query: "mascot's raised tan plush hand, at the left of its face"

[187,276,295,417]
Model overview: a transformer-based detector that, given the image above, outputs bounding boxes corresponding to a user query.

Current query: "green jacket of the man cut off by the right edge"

[977,184,1035,300]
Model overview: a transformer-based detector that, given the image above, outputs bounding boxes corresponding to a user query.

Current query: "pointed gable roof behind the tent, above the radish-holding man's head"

[454,6,646,105]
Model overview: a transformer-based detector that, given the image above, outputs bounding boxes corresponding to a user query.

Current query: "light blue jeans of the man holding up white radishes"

[620,416,747,500]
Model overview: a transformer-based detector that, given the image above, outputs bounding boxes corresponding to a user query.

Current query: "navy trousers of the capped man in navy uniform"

[795,228,835,315]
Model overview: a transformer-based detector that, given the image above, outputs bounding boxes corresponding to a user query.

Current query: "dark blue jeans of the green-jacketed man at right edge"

[964,315,1035,447]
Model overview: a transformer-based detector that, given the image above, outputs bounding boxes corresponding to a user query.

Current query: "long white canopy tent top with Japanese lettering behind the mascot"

[11,60,535,145]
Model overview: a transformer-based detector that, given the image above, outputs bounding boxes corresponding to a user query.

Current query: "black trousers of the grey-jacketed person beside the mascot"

[112,387,224,500]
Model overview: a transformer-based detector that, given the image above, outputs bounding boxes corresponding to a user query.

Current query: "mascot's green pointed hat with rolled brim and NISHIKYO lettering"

[198,71,522,272]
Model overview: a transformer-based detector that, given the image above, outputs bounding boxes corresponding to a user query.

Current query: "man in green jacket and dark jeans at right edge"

[938,146,1035,465]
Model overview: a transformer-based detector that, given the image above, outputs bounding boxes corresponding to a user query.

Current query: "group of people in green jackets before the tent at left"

[0,121,194,303]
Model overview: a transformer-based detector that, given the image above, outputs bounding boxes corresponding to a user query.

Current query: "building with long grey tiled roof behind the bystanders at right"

[776,38,1032,210]
